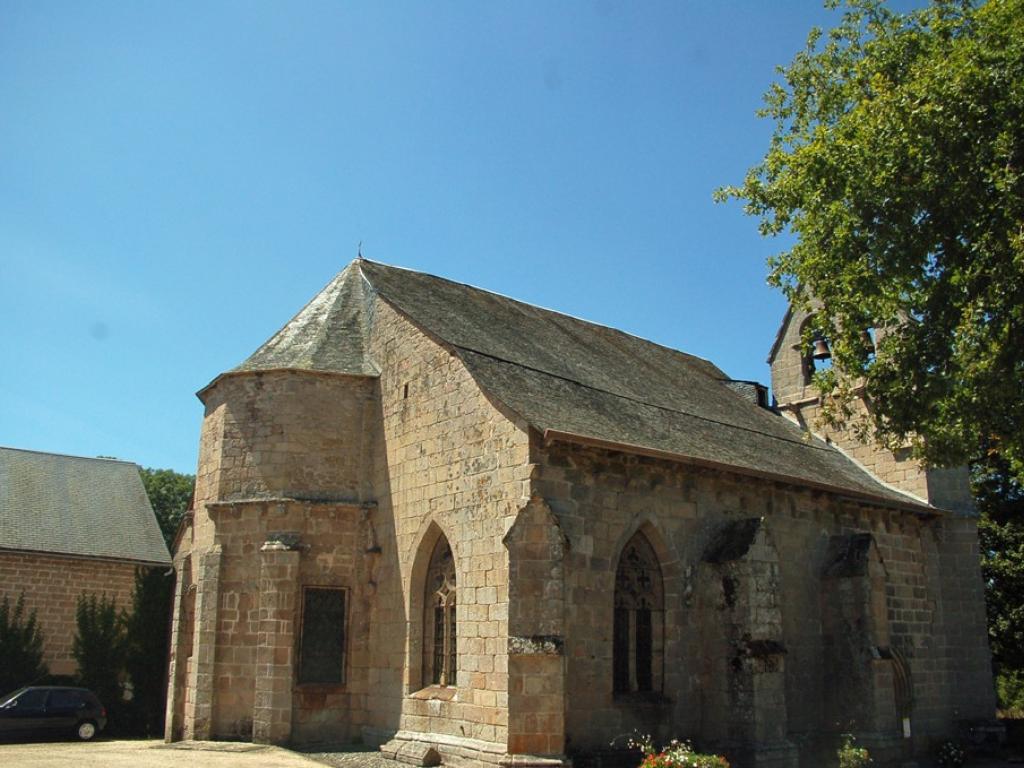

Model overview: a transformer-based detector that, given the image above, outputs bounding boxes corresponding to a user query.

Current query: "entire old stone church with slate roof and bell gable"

[167,259,994,768]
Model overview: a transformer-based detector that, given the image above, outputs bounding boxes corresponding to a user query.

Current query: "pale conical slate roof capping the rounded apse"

[232,260,378,376]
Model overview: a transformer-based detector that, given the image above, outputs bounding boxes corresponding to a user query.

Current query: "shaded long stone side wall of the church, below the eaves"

[534,442,994,765]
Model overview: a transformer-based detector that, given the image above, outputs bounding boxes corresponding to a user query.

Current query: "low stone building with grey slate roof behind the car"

[0,447,171,693]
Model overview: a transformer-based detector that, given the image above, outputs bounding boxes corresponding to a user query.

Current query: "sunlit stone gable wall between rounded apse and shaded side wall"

[369,300,529,762]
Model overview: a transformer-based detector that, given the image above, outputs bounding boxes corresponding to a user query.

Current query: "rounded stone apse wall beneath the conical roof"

[180,371,376,741]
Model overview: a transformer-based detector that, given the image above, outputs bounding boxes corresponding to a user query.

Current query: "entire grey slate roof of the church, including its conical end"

[228,259,927,508]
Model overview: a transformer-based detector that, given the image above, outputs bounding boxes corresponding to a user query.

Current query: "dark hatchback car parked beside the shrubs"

[0,685,106,741]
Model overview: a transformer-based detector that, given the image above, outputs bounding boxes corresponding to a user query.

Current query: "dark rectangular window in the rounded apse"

[299,587,345,684]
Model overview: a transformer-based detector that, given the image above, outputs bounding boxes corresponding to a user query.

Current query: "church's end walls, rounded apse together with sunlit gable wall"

[169,301,529,761]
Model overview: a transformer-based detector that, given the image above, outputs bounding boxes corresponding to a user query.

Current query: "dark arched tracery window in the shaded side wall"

[611,531,665,693]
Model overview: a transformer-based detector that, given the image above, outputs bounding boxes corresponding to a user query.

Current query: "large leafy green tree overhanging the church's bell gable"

[716,0,1024,478]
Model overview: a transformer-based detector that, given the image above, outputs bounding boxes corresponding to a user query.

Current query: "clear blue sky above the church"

[0,0,901,472]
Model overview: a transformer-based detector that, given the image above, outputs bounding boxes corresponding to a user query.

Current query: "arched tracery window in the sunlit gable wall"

[423,536,458,685]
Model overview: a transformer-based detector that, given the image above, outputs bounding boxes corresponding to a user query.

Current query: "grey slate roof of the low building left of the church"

[0,447,171,565]
